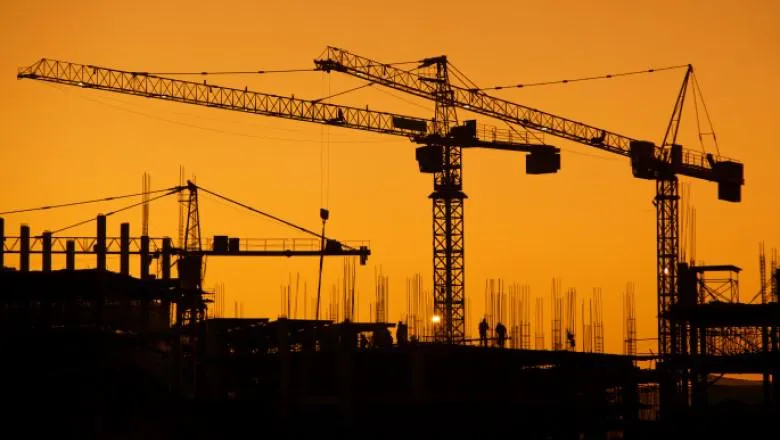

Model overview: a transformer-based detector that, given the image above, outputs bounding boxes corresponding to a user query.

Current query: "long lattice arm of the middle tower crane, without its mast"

[17,58,550,151]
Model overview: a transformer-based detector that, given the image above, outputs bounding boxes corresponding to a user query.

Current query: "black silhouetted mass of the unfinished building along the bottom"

[0,270,778,439]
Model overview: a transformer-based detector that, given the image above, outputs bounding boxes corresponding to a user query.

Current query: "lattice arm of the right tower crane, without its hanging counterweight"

[314,47,741,183]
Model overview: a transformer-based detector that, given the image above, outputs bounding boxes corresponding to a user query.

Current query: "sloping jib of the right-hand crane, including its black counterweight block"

[315,46,744,201]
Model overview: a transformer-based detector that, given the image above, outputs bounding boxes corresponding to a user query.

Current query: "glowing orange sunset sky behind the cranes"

[0,0,780,351]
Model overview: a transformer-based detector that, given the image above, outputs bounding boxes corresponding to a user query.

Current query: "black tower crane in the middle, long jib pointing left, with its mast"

[17,58,560,343]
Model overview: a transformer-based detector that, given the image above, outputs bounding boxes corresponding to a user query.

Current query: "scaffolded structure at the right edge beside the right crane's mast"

[669,262,780,410]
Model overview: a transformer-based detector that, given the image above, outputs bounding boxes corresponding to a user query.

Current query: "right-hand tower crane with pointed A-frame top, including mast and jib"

[314,47,744,370]
